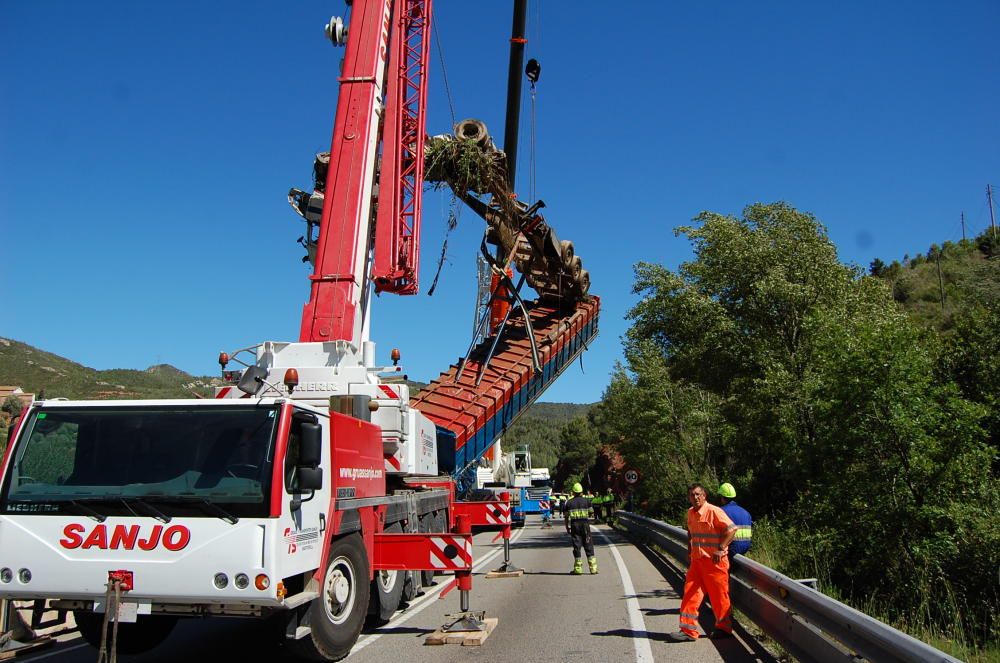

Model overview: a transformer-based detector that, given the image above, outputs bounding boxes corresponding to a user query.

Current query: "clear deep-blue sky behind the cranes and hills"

[0,0,1000,402]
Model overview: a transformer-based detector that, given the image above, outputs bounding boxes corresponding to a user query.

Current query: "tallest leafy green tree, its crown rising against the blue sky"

[627,203,858,511]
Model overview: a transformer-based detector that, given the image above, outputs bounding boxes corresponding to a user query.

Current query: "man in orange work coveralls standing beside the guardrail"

[666,483,736,642]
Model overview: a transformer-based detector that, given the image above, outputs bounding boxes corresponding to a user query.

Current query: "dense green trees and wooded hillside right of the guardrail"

[560,203,1000,660]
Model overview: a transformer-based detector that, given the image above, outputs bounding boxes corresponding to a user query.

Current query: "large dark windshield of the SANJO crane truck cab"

[0,404,279,520]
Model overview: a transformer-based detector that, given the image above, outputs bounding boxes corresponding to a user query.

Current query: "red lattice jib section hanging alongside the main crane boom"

[372,0,431,295]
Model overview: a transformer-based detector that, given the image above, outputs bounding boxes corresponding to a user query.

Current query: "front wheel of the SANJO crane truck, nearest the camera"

[286,533,371,661]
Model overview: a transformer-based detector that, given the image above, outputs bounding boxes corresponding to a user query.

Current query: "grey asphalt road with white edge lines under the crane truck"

[16,520,774,663]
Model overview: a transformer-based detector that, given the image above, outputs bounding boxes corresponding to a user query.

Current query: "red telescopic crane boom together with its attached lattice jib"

[299,0,430,347]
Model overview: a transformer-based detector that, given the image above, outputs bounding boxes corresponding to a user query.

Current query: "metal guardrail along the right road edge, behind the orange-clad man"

[616,511,961,663]
